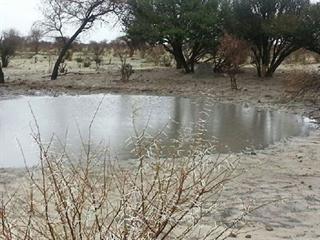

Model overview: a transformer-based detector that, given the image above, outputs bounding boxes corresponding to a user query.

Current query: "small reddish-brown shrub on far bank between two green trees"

[218,34,248,90]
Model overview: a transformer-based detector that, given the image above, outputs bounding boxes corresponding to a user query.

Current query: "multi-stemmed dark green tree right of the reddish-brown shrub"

[228,0,310,77]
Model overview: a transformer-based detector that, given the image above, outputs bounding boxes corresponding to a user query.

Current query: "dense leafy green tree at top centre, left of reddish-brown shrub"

[123,0,222,73]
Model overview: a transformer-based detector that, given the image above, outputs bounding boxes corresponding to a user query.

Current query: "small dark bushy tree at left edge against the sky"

[0,29,21,68]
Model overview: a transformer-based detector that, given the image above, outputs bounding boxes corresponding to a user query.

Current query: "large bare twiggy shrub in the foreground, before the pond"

[0,108,250,240]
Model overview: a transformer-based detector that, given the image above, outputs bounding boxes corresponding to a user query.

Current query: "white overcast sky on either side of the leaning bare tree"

[0,0,121,42]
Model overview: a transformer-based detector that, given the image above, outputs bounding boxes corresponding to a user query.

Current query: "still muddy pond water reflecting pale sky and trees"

[0,95,310,167]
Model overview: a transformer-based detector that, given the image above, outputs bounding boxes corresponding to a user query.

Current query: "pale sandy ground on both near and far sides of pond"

[0,55,320,240]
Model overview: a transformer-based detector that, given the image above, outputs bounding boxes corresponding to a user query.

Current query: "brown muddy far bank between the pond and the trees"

[0,68,320,117]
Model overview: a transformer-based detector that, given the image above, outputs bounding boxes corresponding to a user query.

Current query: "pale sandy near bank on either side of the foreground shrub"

[0,130,320,240]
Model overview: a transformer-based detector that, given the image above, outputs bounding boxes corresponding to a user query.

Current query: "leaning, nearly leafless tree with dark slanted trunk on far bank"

[41,0,122,80]
